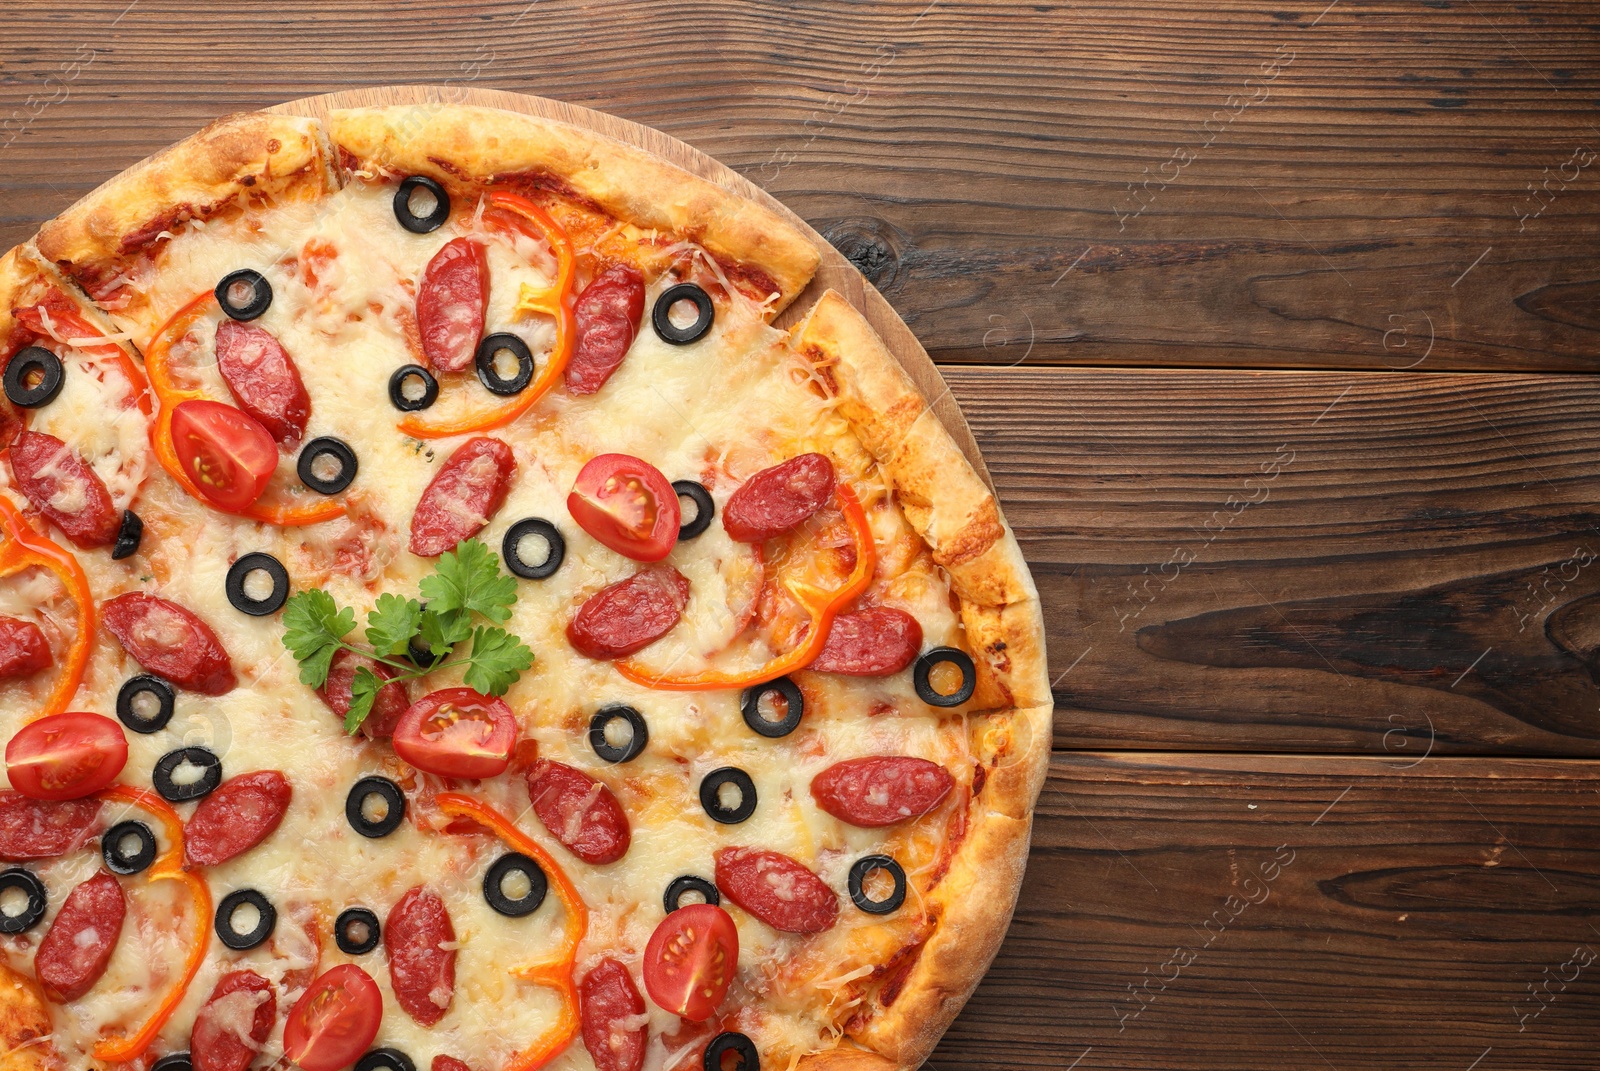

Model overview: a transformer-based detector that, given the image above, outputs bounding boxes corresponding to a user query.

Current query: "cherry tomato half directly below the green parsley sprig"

[394,688,517,778]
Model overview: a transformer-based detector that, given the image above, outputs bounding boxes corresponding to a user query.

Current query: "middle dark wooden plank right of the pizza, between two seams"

[944,367,1600,760]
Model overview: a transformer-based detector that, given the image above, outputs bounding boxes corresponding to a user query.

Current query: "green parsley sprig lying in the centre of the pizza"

[283,540,533,733]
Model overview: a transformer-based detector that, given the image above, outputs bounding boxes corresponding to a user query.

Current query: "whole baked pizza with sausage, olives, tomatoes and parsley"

[0,104,1051,1071]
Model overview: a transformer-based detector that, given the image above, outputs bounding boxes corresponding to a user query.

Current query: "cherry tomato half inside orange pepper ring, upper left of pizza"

[173,402,278,514]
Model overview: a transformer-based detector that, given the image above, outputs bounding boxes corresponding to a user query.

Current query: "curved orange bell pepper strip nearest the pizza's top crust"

[398,191,578,439]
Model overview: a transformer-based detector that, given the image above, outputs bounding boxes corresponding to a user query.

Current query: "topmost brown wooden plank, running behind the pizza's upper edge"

[0,0,1600,370]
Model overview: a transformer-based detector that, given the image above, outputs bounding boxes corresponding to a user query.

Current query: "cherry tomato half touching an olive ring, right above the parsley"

[566,453,683,562]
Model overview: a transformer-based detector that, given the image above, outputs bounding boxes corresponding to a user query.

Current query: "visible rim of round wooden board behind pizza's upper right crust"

[267,85,994,488]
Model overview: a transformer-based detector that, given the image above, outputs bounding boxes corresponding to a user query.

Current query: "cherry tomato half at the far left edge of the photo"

[5,711,128,799]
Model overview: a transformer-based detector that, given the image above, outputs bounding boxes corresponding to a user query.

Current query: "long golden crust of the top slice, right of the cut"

[328,104,819,314]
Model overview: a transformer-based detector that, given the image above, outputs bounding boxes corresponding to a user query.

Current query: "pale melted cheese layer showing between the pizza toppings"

[0,184,971,1071]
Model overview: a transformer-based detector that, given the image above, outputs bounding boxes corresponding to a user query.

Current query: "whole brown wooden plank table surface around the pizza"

[0,0,1600,1071]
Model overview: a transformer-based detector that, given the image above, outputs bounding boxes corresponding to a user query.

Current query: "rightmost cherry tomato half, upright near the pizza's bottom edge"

[645,903,739,1023]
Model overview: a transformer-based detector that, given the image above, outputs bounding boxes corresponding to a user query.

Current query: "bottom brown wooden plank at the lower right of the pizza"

[930,754,1600,1071]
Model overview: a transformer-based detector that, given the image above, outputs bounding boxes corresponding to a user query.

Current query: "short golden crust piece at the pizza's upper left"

[35,112,338,291]
